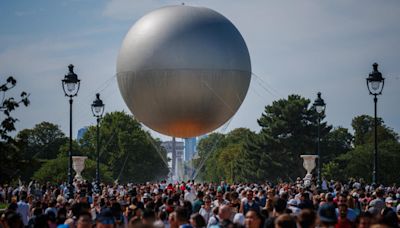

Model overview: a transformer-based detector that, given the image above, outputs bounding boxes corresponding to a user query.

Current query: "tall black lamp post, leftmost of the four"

[61,64,81,199]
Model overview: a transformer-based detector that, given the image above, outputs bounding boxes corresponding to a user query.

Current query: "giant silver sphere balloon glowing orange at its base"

[117,5,251,138]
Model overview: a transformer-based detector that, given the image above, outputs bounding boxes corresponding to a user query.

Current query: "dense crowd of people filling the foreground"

[0,179,400,228]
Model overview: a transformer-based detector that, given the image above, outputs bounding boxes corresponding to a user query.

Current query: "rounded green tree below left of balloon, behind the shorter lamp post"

[80,112,169,182]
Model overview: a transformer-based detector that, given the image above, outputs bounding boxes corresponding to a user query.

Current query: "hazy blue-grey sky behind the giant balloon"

[0,0,400,142]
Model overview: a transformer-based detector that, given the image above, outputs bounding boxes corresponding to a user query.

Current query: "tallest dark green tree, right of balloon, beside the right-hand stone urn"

[248,95,332,180]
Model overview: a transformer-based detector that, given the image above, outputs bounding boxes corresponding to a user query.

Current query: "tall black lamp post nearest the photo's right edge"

[367,63,385,184]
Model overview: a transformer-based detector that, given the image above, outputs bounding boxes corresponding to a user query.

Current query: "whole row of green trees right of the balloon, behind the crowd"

[194,95,400,184]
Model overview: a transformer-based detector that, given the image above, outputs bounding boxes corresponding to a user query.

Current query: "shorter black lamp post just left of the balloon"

[92,93,104,193]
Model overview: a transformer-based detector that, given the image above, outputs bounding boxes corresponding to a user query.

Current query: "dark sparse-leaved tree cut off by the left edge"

[0,76,29,183]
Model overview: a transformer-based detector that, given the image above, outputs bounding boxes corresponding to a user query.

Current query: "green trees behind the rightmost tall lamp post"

[323,115,400,184]
